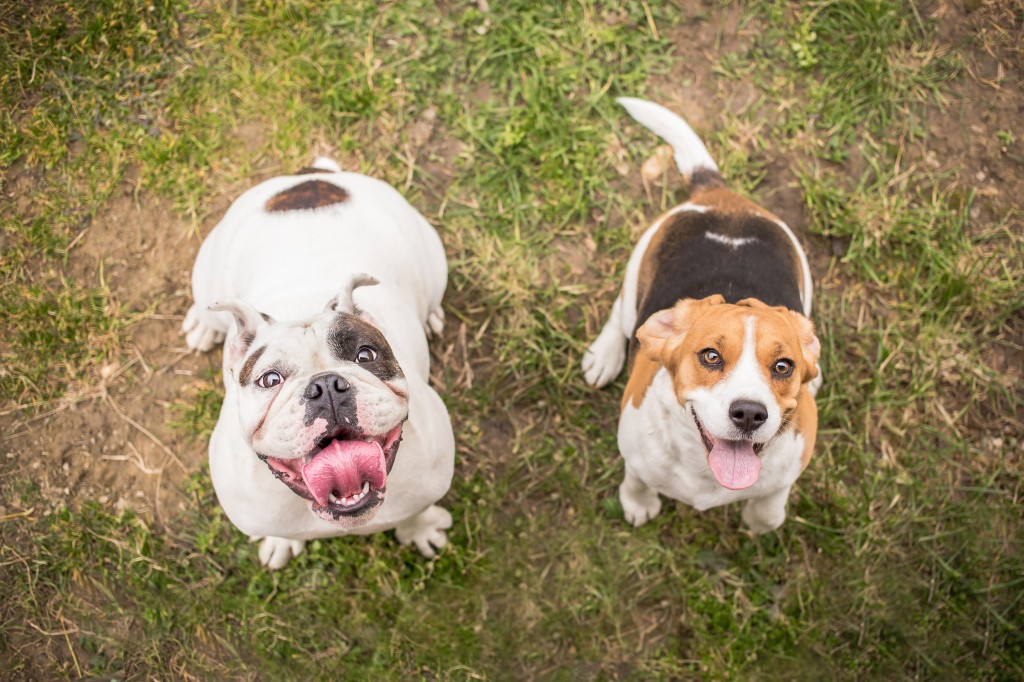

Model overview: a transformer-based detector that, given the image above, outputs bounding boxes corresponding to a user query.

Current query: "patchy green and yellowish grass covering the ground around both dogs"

[0,0,1024,680]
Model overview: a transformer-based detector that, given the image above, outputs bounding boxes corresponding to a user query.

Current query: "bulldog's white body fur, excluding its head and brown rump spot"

[183,158,455,568]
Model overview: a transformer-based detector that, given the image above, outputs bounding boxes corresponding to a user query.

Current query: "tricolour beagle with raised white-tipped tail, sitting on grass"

[583,97,821,534]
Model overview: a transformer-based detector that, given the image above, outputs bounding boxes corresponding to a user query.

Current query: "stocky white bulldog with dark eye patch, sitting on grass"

[182,158,455,569]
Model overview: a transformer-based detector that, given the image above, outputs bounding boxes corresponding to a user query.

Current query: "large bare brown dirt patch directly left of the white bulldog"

[6,183,219,522]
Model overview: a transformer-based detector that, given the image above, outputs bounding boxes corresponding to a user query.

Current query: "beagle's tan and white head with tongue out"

[637,295,821,489]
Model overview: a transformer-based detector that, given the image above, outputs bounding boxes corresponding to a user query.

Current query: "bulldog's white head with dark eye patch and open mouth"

[210,275,409,527]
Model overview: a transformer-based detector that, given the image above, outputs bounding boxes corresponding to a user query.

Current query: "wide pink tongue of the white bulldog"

[302,440,387,506]
